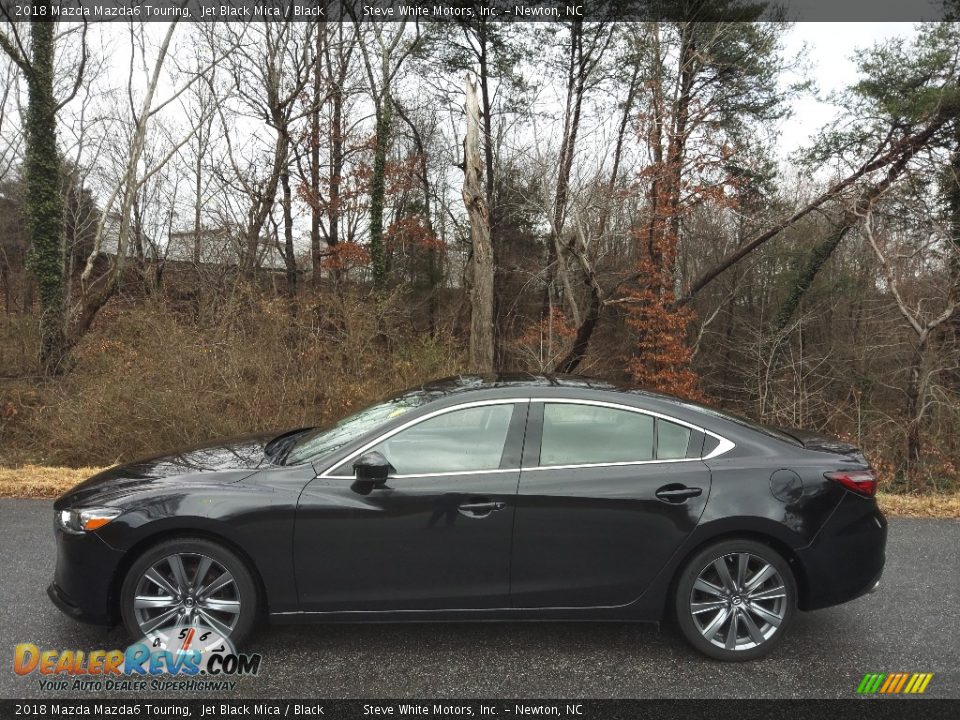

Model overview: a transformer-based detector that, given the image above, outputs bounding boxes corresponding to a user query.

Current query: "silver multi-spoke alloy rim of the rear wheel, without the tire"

[690,552,787,650]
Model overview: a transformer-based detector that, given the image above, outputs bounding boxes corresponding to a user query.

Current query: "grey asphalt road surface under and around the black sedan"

[0,499,960,699]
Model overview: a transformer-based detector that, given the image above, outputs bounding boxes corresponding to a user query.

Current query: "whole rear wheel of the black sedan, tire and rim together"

[673,540,797,662]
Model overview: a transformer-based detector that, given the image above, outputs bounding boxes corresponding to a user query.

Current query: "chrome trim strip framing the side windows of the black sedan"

[317,397,736,480]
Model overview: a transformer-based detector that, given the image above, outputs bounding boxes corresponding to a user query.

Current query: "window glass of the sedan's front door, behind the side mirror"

[335,404,514,476]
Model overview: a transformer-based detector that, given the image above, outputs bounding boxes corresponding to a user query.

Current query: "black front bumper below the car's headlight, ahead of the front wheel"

[47,529,123,625]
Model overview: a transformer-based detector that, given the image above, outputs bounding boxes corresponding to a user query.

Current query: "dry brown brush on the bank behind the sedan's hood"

[0,291,463,465]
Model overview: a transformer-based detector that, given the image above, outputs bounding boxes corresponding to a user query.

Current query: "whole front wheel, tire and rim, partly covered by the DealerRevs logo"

[120,538,257,650]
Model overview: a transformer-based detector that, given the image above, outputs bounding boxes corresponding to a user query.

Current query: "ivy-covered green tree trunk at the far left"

[24,19,68,375]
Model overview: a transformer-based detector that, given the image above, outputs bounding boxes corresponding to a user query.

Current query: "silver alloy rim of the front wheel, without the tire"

[133,553,240,647]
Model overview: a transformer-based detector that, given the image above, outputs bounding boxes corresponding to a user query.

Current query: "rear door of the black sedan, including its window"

[511,400,710,608]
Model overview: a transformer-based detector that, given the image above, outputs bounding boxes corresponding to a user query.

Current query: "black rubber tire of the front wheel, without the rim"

[120,537,260,648]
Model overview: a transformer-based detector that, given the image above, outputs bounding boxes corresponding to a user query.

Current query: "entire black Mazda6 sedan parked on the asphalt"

[49,375,887,660]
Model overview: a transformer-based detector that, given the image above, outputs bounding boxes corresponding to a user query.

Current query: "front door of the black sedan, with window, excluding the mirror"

[294,400,528,612]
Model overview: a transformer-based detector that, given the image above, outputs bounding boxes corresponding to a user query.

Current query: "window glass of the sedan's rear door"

[540,403,699,467]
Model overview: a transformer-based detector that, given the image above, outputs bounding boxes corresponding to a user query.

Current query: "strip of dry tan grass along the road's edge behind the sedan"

[0,465,960,519]
